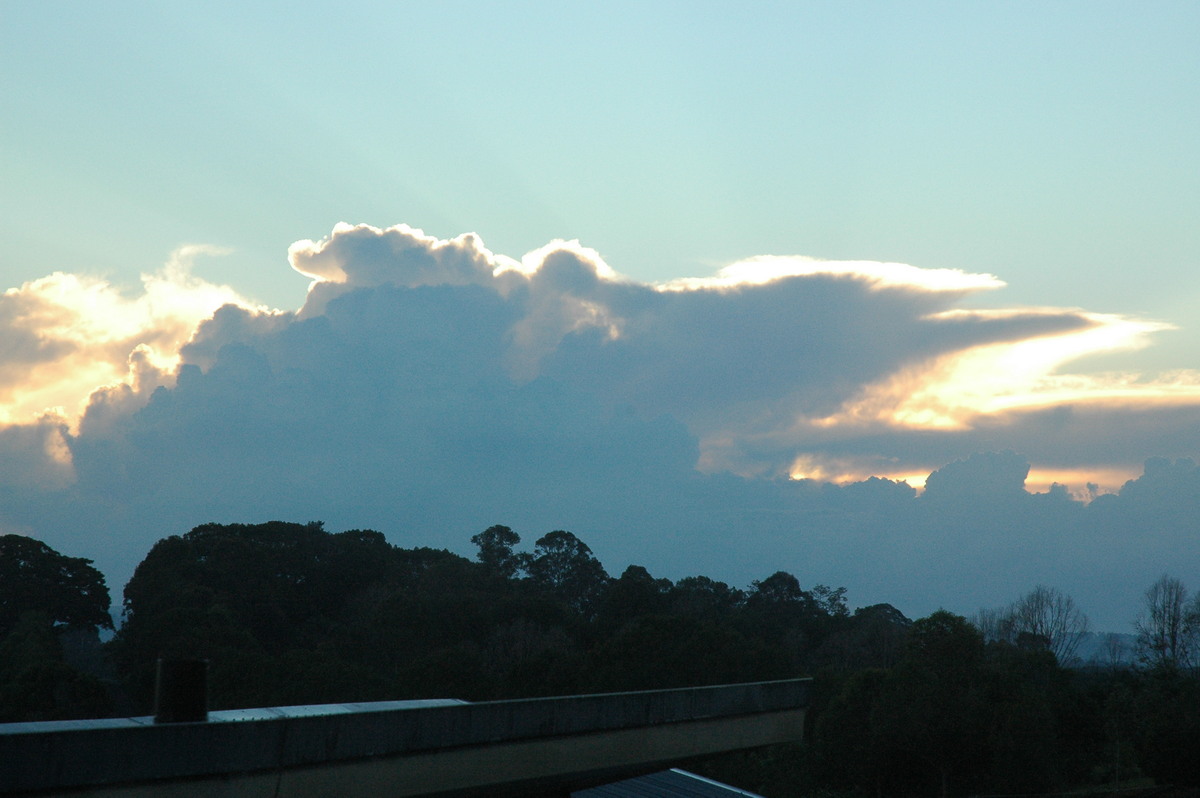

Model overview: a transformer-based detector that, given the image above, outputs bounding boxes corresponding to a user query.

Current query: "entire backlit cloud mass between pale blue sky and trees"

[0,218,1200,618]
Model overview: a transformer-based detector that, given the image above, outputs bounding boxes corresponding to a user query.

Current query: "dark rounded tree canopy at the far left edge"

[0,535,113,637]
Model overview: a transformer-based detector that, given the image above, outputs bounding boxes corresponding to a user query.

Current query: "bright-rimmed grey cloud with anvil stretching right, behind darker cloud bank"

[283,224,1200,489]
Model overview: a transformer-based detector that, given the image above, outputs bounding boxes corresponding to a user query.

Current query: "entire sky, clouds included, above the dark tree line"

[0,1,1200,630]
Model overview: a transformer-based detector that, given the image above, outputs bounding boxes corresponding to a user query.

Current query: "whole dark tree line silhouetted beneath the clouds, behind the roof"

[0,522,1200,797]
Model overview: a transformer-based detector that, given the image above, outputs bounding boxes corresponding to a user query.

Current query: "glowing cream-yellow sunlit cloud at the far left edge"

[0,245,248,424]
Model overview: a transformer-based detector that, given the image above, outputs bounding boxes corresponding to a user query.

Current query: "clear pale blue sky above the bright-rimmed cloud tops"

[0,0,1200,370]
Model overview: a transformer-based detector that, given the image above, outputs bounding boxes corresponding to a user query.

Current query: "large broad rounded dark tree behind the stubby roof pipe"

[112,522,403,708]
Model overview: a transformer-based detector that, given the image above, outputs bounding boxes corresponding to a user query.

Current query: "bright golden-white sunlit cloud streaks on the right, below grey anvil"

[788,308,1200,492]
